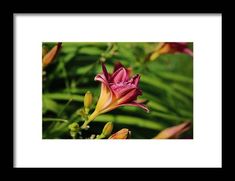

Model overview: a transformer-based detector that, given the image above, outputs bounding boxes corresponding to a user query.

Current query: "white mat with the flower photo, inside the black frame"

[14,14,222,168]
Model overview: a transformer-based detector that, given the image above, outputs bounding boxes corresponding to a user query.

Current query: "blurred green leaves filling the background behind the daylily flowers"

[42,42,193,139]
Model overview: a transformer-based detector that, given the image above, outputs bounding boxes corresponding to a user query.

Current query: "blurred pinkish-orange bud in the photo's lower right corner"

[153,122,192,139]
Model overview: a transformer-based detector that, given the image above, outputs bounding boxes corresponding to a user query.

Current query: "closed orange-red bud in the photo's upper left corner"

[42,43,62,68]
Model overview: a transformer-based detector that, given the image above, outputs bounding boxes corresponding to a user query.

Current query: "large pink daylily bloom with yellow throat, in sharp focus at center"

[83,63,149,128]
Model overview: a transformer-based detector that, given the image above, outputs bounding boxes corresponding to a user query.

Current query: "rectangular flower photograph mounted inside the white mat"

[42,42,193,139]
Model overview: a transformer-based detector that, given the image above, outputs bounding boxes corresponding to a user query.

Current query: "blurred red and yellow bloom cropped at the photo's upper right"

[147,42,193,61]
